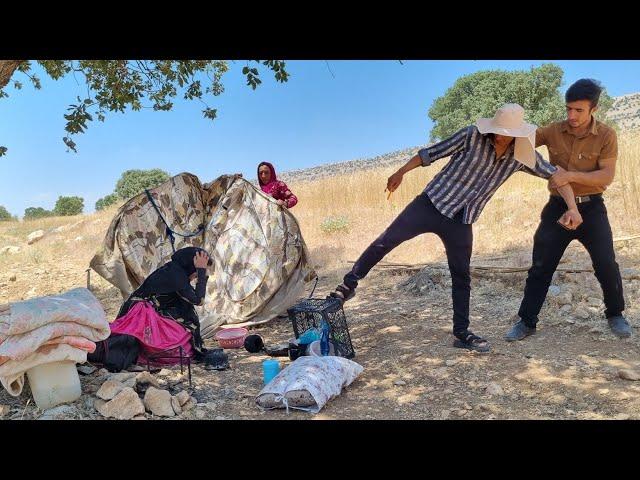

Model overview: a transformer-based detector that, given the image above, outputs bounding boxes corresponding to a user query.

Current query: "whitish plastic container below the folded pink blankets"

[27,360,82,410]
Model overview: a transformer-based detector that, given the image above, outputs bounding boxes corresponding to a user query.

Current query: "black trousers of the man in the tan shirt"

[518,196,624,327]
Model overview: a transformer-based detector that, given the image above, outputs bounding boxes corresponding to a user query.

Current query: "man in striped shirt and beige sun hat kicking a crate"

[331,104,582,352]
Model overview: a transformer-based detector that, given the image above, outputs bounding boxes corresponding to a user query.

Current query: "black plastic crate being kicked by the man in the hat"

[287,297,356,358]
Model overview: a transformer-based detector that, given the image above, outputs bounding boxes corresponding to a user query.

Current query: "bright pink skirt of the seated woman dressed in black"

[111,301,193,365]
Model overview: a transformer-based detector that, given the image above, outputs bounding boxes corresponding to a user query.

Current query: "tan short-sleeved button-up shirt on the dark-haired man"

[536,117,618,196]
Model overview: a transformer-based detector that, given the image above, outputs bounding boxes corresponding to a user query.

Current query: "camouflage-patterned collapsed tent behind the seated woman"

[91,173,316,338]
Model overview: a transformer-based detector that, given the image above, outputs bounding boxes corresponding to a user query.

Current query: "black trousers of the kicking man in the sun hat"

[344,193,473,338]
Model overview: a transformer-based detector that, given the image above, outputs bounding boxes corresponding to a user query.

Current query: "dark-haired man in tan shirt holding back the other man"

[505,79,631,341]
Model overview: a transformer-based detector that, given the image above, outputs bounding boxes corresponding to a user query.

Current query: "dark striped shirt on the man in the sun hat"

[418,125,557,224]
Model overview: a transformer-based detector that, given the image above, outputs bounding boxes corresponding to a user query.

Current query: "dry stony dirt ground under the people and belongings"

[0,240,640,420]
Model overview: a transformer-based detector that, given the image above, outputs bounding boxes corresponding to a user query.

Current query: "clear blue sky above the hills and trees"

[0,60,640,216]
